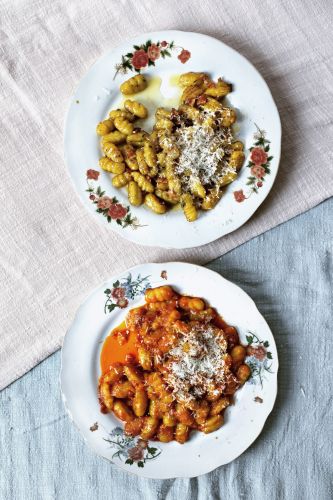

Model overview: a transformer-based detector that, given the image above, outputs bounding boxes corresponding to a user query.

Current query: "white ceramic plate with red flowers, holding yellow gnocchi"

[64,31,281,248]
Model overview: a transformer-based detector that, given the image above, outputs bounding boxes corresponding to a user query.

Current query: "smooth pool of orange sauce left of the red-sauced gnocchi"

[100,322,138,374]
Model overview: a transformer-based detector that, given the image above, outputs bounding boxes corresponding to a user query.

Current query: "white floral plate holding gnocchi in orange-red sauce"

[61,262,278,479]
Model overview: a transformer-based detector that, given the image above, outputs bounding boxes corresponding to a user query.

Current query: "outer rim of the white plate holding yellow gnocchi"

[62,30,282,250]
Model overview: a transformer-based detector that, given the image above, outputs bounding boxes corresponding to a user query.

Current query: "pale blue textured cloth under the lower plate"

[0,199,333,500]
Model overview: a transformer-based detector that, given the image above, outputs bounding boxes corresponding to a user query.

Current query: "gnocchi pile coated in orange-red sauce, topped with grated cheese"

[99,286,251,444]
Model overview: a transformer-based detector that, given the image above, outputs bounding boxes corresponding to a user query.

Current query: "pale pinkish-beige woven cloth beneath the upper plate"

[0,0,333,387]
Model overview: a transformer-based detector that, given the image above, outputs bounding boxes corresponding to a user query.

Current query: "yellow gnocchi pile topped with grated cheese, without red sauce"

[96,72,245,222]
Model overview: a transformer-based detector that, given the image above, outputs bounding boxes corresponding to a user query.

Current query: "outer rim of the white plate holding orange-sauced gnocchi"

[59,261,279,480]
